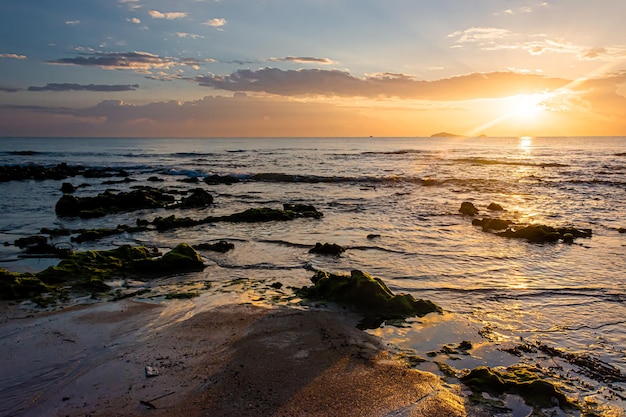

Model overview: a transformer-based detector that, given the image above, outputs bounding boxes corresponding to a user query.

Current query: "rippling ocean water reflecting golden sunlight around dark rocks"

[0,137,626,416]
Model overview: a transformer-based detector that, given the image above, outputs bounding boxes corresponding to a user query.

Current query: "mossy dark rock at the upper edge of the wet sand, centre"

[298,270,442,319]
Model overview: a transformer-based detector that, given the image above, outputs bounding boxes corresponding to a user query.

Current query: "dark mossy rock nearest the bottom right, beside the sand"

[461,366,578,409]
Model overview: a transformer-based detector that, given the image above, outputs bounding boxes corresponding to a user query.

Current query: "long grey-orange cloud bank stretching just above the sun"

[195,68,569,100]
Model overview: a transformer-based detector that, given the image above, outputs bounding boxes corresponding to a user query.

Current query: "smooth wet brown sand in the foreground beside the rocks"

[0,300,477,417]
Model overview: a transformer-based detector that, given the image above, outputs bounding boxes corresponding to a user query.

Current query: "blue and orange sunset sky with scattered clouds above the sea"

[0,0,626,137]
